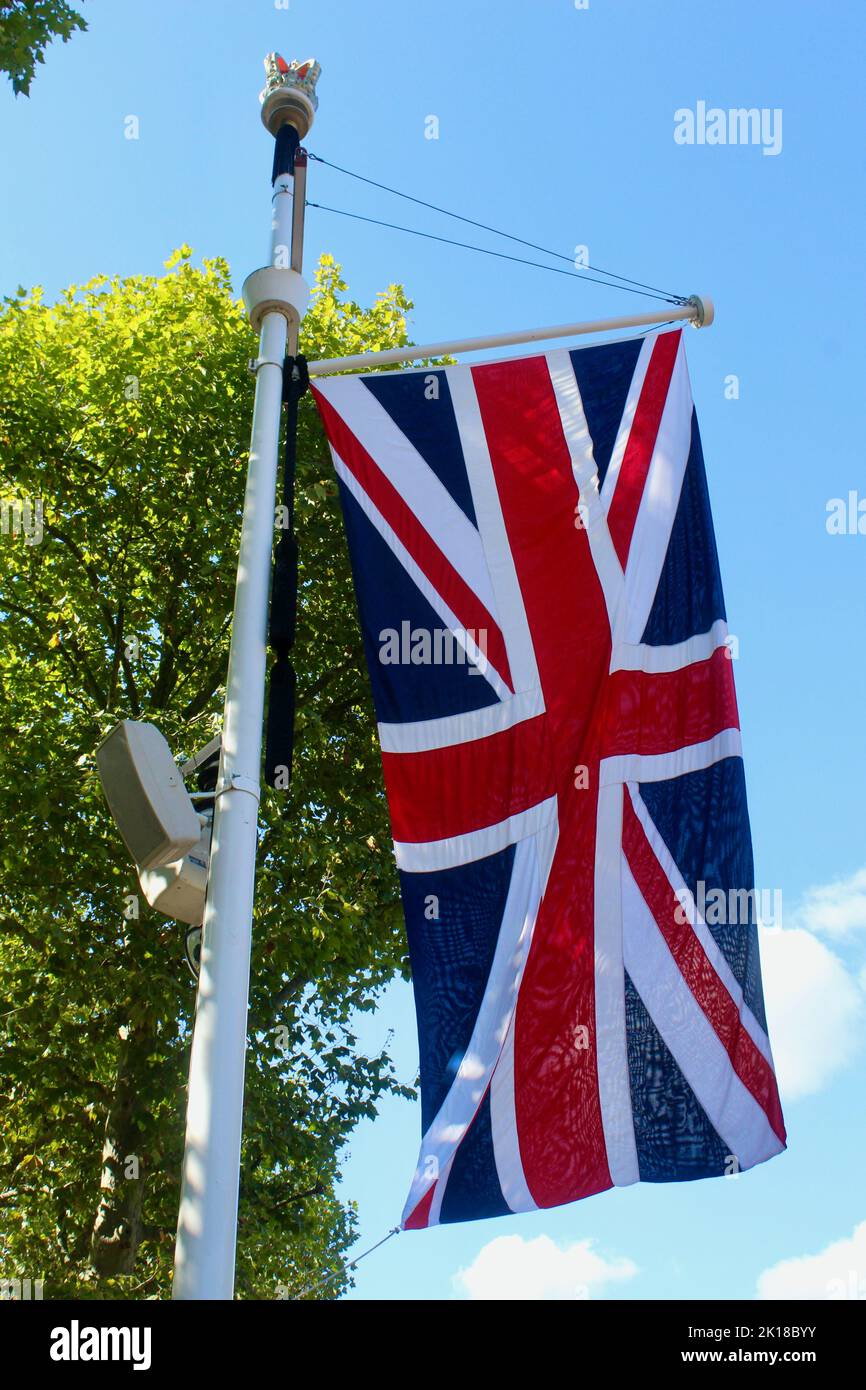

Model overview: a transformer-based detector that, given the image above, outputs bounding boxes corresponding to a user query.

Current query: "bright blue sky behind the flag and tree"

[0,0,866,1298]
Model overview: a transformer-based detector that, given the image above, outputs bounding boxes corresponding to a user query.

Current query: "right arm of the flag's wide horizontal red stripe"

[602,646,740,758]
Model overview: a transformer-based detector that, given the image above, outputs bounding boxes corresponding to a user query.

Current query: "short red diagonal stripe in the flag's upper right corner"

[607,328,681,569]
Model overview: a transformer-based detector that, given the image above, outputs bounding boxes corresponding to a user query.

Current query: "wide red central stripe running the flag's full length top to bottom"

[473,357,612,1207]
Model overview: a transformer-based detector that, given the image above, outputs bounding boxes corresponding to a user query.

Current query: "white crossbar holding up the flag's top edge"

[309,295,714,377]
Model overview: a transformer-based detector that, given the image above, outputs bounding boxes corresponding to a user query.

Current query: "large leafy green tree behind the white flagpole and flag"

[0,247,409,1298]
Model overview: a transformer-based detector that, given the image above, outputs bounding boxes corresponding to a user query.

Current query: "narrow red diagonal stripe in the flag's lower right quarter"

[623,796,785,1144]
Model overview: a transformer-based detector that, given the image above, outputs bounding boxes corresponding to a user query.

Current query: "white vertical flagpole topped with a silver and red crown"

[172,54,320,1300]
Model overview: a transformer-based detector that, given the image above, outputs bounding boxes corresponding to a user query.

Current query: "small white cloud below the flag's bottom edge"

[453,1236,638,1301]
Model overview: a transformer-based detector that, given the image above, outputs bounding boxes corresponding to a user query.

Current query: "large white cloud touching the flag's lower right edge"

[760,927,863,1101]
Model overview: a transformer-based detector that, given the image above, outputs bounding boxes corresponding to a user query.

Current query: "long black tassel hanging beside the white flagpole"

[264,353,310,790]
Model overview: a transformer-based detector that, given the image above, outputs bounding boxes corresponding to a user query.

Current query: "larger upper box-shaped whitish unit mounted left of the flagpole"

[96,719,202,870]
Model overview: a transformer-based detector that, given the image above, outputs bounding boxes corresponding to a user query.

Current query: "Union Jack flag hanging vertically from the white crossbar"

[314,331,785,1227]
